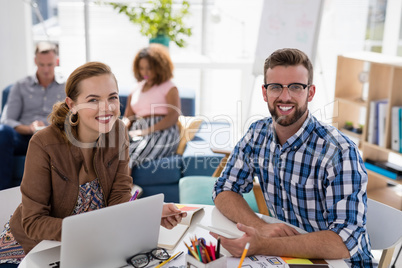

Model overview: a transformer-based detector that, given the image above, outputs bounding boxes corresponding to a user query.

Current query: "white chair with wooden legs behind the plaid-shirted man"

[367,199,402,268]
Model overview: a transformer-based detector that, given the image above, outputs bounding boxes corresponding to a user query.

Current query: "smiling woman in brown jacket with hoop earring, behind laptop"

[0,62,186,267]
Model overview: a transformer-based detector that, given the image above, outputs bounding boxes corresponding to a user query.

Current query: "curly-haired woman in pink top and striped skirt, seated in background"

[123,44,181,168]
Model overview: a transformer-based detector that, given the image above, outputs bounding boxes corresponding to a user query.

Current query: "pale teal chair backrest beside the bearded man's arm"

[179,176,258,212]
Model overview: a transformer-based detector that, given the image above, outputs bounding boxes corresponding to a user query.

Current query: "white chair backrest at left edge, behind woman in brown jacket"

[0,186,21,226]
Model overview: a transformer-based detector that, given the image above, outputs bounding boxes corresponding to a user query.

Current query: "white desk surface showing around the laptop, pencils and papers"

[18,205,348,268]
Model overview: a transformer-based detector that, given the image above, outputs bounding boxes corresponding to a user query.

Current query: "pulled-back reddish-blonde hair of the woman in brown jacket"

[49,62,117,139]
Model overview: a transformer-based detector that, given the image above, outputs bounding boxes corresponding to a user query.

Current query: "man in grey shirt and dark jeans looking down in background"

[0,42,65,190]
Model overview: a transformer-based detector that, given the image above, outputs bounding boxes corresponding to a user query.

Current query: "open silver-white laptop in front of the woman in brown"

[26,194,164,268]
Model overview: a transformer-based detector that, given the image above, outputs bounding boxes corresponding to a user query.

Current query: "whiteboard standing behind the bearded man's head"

[253,0,324,76]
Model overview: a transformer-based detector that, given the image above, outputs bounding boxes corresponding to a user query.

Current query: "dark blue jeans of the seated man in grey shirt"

[0,124,32,190]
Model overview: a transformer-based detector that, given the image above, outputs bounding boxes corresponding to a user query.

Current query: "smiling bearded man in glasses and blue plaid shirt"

[213,49,373,267]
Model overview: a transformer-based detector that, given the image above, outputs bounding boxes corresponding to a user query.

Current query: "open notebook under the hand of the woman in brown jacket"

[158,204,203,250]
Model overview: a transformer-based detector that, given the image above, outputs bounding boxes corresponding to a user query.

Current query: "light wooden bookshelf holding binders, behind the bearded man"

[333,52,402,210]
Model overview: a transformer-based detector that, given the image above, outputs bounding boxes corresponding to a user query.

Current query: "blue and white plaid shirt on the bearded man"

[213,113,373,267]
